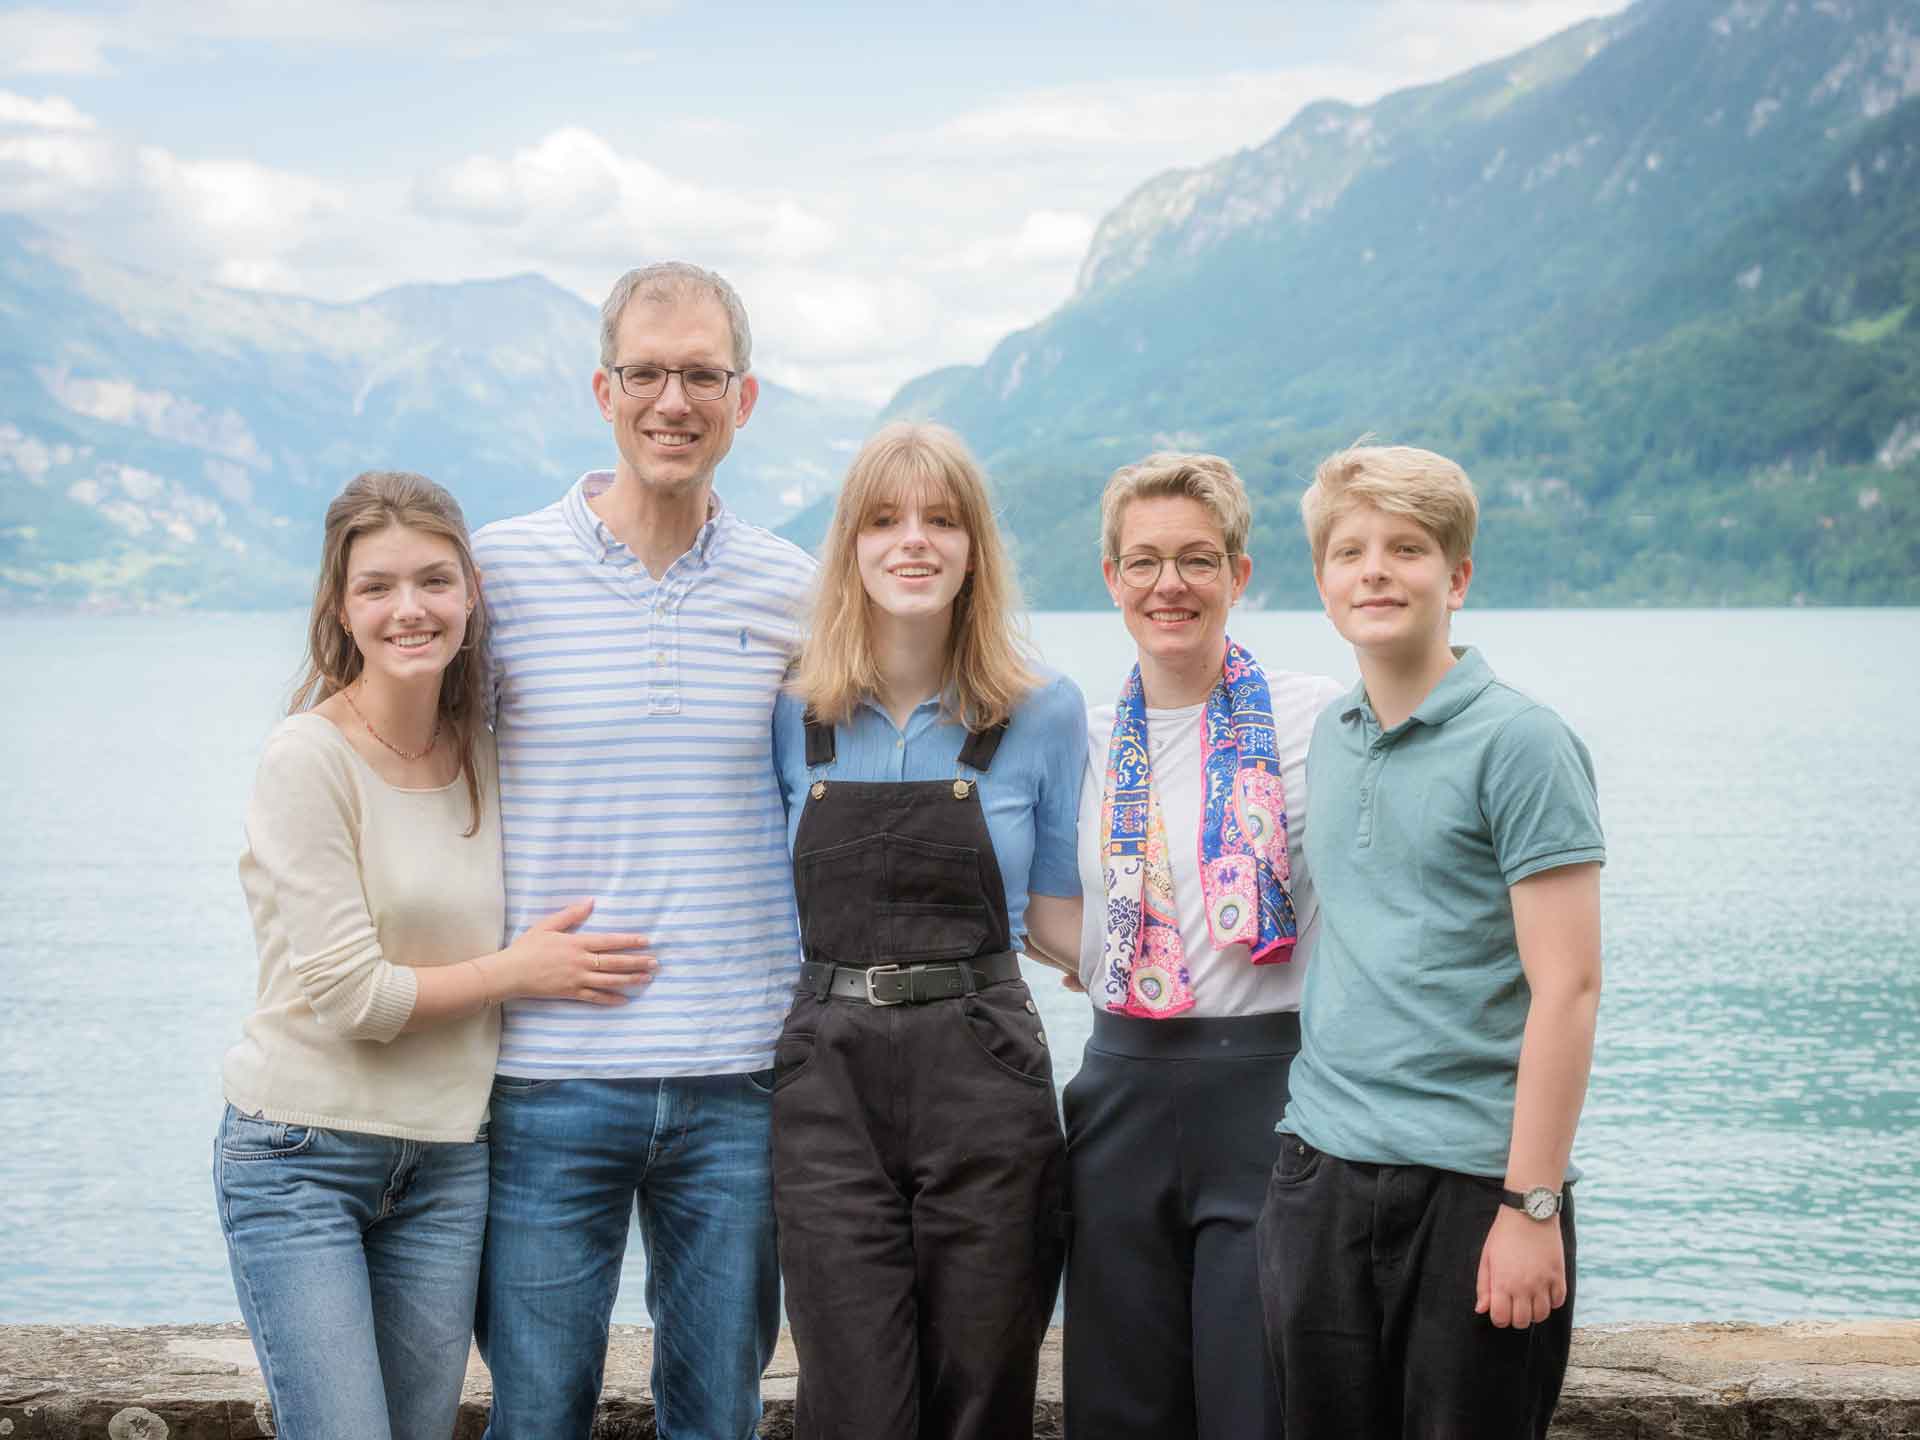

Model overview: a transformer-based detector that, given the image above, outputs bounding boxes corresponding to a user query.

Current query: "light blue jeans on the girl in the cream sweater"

[213,1106,488,1440]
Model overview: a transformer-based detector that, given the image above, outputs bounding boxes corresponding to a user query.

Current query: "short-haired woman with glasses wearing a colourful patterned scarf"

[1064,455,1342,1440]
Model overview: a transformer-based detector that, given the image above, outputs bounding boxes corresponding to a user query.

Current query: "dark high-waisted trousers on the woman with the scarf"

[1064,1010,1300,1440]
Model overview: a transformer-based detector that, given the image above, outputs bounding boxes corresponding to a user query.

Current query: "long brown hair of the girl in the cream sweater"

[286,470,488,835]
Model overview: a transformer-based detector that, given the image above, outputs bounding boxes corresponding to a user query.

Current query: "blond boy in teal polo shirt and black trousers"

[1258,445,1605,1440]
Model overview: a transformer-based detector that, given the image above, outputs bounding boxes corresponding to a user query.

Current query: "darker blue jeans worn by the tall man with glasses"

[474,1069,780,1440]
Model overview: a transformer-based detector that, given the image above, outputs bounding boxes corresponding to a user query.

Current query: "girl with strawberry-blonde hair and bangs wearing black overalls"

[774,424,1087,1440]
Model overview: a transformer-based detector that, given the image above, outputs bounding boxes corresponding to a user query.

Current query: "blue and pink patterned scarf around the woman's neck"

[1100,639,1294,1020]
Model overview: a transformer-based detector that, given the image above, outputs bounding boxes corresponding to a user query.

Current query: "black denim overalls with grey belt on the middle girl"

[774,724,1066,1440]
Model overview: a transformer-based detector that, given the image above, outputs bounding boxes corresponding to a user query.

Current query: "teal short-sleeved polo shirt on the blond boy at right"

[1281,649,1607,1179]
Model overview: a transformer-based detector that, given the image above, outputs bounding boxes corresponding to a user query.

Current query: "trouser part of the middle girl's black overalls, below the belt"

[774,979,1066,1440]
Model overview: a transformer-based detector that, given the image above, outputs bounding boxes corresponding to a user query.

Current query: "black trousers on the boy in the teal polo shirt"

[1260,1135,1574,1440]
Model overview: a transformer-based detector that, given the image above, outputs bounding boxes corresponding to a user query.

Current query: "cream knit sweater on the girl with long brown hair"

[221,712,503,1140]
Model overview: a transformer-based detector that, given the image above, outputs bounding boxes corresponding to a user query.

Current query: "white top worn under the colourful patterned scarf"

[1079,670,1346,1018]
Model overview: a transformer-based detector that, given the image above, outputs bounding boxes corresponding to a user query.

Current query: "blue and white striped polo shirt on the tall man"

[474,470,814,1079]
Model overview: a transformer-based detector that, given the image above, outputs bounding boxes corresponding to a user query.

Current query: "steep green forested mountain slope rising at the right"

[871,0,1920,605]
